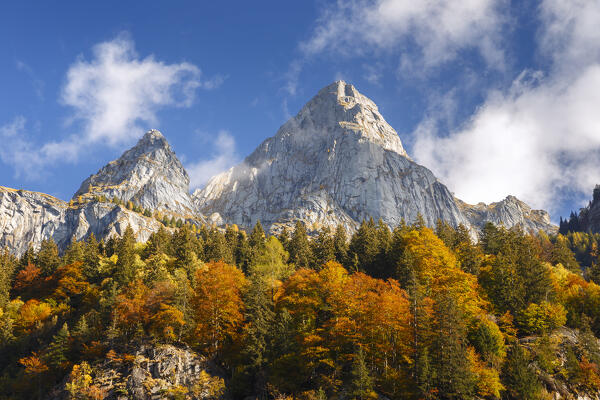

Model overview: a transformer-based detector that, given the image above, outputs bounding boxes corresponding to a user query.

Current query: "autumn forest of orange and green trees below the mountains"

[0,219,600,400]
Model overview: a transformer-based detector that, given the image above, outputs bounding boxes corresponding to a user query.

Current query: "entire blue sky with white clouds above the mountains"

[0,0,600,220]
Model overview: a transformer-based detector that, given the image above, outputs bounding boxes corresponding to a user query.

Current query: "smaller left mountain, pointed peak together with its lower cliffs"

[0,130,204,254]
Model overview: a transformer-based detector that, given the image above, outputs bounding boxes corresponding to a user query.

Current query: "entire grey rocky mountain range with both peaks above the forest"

[0,81,556,253]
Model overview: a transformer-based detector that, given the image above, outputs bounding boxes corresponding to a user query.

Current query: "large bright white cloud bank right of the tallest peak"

[413,0,600,211]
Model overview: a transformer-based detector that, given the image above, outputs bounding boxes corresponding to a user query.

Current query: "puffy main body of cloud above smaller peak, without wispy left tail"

[61,36,203,145]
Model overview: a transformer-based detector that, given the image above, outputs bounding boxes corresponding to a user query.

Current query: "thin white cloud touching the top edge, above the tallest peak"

[301,0,506,68]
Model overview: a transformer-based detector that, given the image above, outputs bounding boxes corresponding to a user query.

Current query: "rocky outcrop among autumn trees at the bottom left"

[48,345,225,400]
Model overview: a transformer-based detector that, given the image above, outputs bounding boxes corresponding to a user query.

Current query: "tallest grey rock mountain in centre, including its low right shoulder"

[193,81,556,231]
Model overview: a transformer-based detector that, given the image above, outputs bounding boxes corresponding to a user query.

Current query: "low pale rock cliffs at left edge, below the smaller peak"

[0,186,162,255]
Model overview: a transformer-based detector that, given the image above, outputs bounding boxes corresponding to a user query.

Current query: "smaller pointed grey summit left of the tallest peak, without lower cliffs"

[73,129,196,216]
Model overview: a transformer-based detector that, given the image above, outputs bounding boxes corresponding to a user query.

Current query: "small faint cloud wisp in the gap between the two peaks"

[186,131,239,190]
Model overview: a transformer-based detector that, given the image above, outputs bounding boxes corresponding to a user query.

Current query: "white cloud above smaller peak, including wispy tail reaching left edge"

[0,34,220,179]
